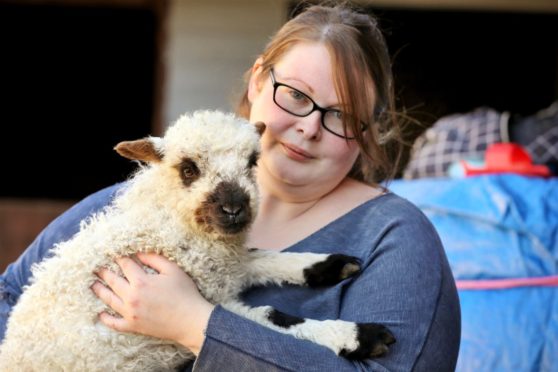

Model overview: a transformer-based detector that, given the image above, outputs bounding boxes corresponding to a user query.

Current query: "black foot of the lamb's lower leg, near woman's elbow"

[339,323,395,360]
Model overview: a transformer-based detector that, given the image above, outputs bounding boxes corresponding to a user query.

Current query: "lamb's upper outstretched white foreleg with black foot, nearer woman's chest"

[245,249,360,287]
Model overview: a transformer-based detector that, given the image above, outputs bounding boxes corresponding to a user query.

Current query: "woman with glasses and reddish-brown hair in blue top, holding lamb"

[2,6,460,371]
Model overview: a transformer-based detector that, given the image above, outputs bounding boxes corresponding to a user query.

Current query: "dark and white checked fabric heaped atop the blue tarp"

[403,101,558,179]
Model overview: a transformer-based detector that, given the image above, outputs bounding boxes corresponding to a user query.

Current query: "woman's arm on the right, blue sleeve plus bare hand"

[91,196,459,371]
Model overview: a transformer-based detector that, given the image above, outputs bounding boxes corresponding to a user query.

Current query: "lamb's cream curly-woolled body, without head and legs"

[0,189,247,371]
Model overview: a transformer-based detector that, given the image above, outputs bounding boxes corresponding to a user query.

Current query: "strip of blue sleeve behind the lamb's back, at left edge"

[0,184,120,341]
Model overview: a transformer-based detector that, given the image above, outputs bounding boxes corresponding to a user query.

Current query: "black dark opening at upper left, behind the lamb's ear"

[0,2,162,199]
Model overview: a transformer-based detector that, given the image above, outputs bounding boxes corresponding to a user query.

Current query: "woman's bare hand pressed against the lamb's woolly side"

[92,253,214,355]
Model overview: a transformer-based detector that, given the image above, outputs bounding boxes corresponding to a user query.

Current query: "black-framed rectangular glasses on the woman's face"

[269,69,368,139]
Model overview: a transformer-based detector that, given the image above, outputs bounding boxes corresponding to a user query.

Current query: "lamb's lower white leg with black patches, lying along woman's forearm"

[222,301,395,360]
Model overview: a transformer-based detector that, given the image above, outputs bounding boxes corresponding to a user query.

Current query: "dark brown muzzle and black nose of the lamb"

[196,182,252,235]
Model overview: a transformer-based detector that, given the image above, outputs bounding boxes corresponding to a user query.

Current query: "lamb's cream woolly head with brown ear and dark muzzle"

[115,111,265,237]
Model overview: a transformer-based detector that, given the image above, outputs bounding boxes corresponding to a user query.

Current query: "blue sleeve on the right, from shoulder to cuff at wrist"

[194,196,460,372]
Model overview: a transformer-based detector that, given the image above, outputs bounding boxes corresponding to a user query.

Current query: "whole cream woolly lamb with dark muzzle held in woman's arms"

[0,111,394,371]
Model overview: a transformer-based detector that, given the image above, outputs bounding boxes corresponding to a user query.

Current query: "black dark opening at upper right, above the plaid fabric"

[370,8,558,124]
